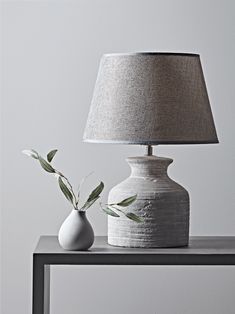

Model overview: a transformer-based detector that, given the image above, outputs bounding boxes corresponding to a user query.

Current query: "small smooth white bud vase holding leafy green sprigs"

[58,209,94,251]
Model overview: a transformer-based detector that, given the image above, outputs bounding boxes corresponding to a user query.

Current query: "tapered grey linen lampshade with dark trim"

[84,52,218,145]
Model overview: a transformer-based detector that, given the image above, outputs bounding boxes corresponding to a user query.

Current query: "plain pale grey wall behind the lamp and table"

[1,0,235,314]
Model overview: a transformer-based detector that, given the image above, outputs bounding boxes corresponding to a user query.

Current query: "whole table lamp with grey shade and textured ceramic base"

[84,52,218,248]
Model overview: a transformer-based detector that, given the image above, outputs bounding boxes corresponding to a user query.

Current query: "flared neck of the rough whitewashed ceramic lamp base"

[126,156,173,178]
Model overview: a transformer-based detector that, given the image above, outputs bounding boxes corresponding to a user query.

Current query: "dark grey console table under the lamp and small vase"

[32,236,235,314]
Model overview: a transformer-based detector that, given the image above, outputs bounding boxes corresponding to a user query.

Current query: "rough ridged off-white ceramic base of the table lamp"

[108,156,189,248]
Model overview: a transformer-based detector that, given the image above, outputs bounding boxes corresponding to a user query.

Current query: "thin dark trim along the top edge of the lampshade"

[104,51,200,57]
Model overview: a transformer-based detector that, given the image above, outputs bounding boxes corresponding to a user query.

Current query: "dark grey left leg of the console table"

[32,255,50,314]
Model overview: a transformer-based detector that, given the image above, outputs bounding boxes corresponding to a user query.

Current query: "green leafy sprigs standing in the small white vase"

[22,149,143,222]
